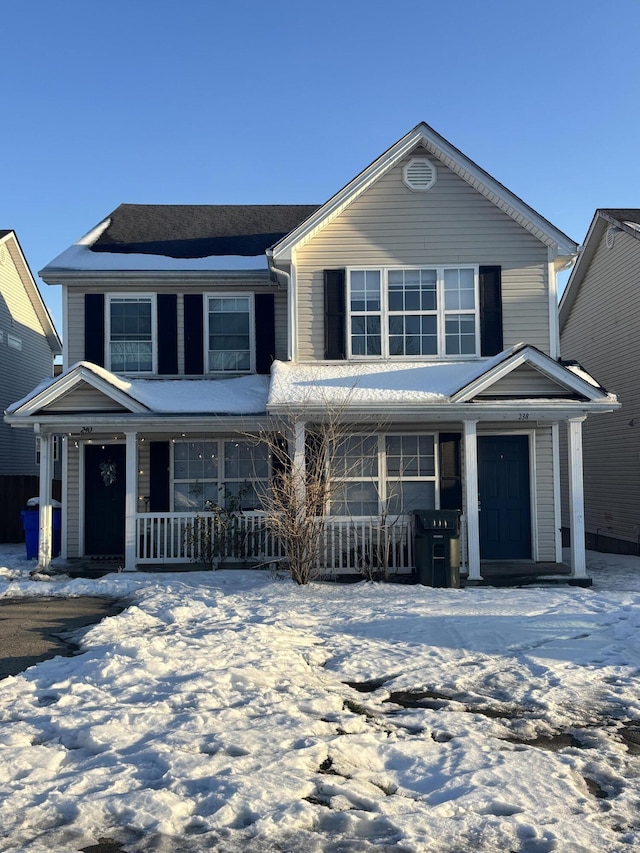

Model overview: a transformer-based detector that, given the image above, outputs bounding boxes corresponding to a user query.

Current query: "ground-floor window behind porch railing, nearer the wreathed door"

[172,439,270,512]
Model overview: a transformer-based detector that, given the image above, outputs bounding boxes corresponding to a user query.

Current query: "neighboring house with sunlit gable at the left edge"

[0,230,62,542]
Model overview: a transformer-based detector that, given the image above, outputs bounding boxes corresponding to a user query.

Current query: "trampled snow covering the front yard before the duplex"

[0,546,640,853]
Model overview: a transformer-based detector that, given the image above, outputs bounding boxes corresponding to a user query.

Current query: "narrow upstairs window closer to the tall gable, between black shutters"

[206,295,255,373]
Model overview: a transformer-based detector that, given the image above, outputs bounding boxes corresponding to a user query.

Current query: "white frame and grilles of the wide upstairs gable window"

[346,263,480,362]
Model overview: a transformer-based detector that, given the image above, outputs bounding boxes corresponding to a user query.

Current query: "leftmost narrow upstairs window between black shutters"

[106,295,156,373]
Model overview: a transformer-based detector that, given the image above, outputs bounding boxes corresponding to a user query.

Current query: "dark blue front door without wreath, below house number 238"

[478,435,531,560]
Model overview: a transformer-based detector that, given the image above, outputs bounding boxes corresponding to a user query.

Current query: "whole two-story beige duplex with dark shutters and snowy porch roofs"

[2,124,618,581]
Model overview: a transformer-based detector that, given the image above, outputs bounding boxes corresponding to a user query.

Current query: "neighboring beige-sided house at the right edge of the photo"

[560,208,640,554]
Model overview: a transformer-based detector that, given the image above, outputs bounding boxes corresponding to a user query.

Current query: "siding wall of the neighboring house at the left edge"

[0,243,53,475]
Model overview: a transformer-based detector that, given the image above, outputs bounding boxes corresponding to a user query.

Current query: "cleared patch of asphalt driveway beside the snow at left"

[0,596,126,678]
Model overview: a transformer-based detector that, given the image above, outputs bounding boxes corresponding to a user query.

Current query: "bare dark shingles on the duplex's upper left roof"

[91,204,318,258]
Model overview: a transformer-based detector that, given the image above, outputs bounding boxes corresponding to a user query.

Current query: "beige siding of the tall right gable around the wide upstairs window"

[296,155,549,361]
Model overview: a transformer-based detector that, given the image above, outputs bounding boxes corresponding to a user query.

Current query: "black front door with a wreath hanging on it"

[84,444,125,556]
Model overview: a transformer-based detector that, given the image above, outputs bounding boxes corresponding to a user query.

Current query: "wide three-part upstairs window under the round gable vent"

[348,266,480,358]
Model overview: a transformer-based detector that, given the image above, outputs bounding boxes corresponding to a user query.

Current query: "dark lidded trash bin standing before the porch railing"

[413,509,460,589]
